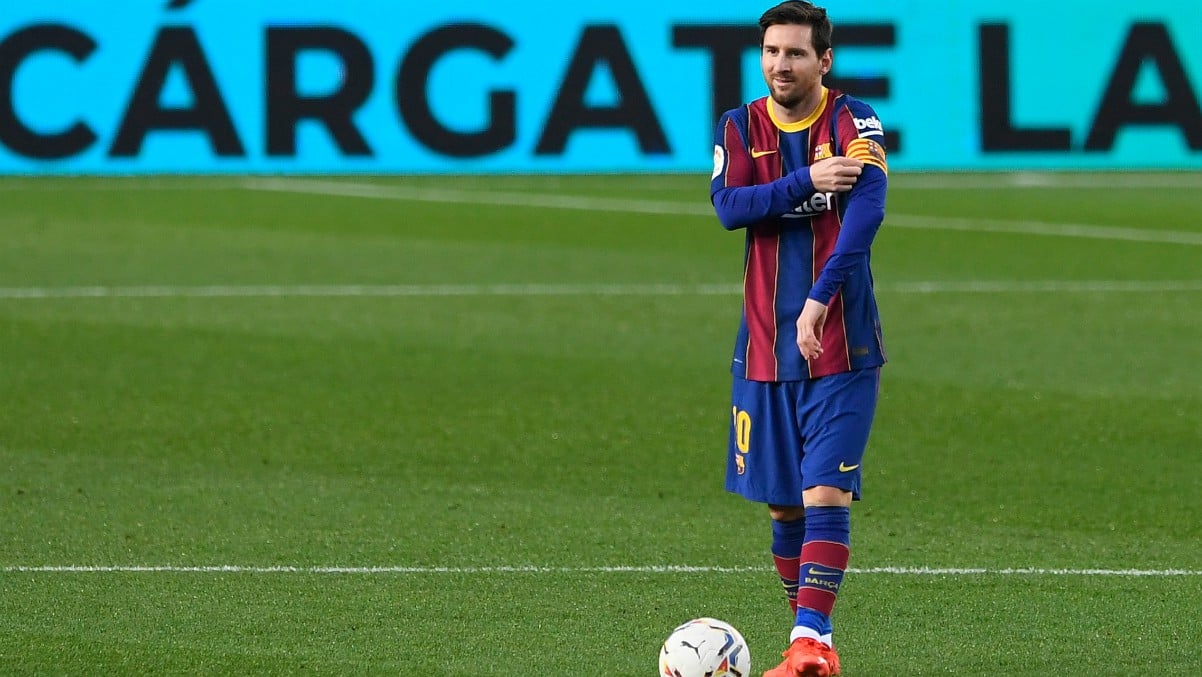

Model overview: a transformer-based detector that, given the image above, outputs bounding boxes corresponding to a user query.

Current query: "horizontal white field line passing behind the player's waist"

[0,280,1202,299]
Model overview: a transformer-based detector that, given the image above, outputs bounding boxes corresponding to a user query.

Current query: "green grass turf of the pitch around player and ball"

[0,174,1202,676]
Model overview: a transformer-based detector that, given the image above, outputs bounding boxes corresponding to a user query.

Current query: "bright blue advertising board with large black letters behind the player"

[0,0,1202,174]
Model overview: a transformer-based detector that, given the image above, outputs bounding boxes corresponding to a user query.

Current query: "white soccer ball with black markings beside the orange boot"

[660,618,751,677]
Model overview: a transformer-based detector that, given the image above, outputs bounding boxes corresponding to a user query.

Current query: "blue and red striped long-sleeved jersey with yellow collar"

[710,88,888,381]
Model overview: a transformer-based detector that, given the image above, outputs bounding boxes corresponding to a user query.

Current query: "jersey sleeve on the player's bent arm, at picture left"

[709,108,814,231]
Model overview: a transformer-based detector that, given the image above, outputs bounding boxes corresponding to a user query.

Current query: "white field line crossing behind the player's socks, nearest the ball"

[0,565,1202,577]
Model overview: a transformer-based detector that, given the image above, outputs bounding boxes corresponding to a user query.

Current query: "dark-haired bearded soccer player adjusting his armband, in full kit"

[710,0,887,677]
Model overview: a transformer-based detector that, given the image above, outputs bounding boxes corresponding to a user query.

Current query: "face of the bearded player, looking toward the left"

[760,24,831,113]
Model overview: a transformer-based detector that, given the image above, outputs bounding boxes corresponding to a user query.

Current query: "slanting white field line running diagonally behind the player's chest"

[242,178,1202,247]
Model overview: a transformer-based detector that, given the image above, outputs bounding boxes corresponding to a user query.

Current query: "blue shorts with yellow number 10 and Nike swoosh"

[726,367,881,505]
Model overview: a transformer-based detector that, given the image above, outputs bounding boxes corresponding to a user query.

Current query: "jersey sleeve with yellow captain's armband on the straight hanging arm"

[809,97,888,304]
